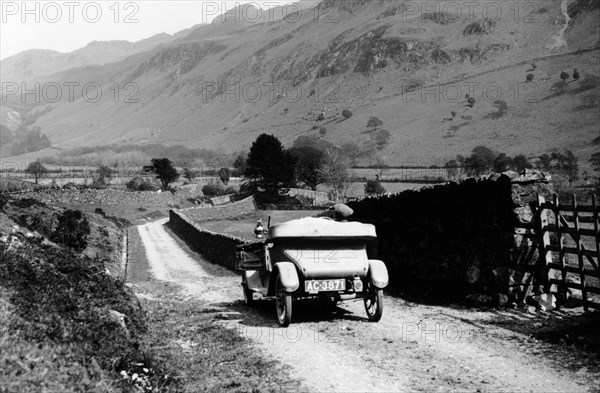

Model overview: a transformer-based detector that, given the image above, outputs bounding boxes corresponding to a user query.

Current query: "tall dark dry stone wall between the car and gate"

[349,172,551,304]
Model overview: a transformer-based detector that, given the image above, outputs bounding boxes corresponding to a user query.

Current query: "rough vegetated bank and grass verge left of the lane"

[0,196,308,392]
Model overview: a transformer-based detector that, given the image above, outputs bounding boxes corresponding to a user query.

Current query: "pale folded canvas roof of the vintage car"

[269,217,377,239]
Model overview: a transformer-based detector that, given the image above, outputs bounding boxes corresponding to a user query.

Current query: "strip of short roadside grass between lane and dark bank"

[135,282,306,392]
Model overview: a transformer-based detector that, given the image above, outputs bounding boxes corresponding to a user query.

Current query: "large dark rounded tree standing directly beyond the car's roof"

[242,134,295,199]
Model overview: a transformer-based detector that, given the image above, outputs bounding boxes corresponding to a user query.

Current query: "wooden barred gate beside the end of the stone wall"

[538,194,600,311]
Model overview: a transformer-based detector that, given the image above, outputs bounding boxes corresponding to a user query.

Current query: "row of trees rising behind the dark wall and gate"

[445,146,579,185]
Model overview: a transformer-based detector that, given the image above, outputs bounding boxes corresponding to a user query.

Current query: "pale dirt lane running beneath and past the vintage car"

[137,220,600,392]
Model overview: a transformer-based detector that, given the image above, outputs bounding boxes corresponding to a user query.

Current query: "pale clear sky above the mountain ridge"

[0,0,300,60]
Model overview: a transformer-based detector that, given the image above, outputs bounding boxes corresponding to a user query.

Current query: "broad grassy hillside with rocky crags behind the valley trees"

[1,0,600,164]
